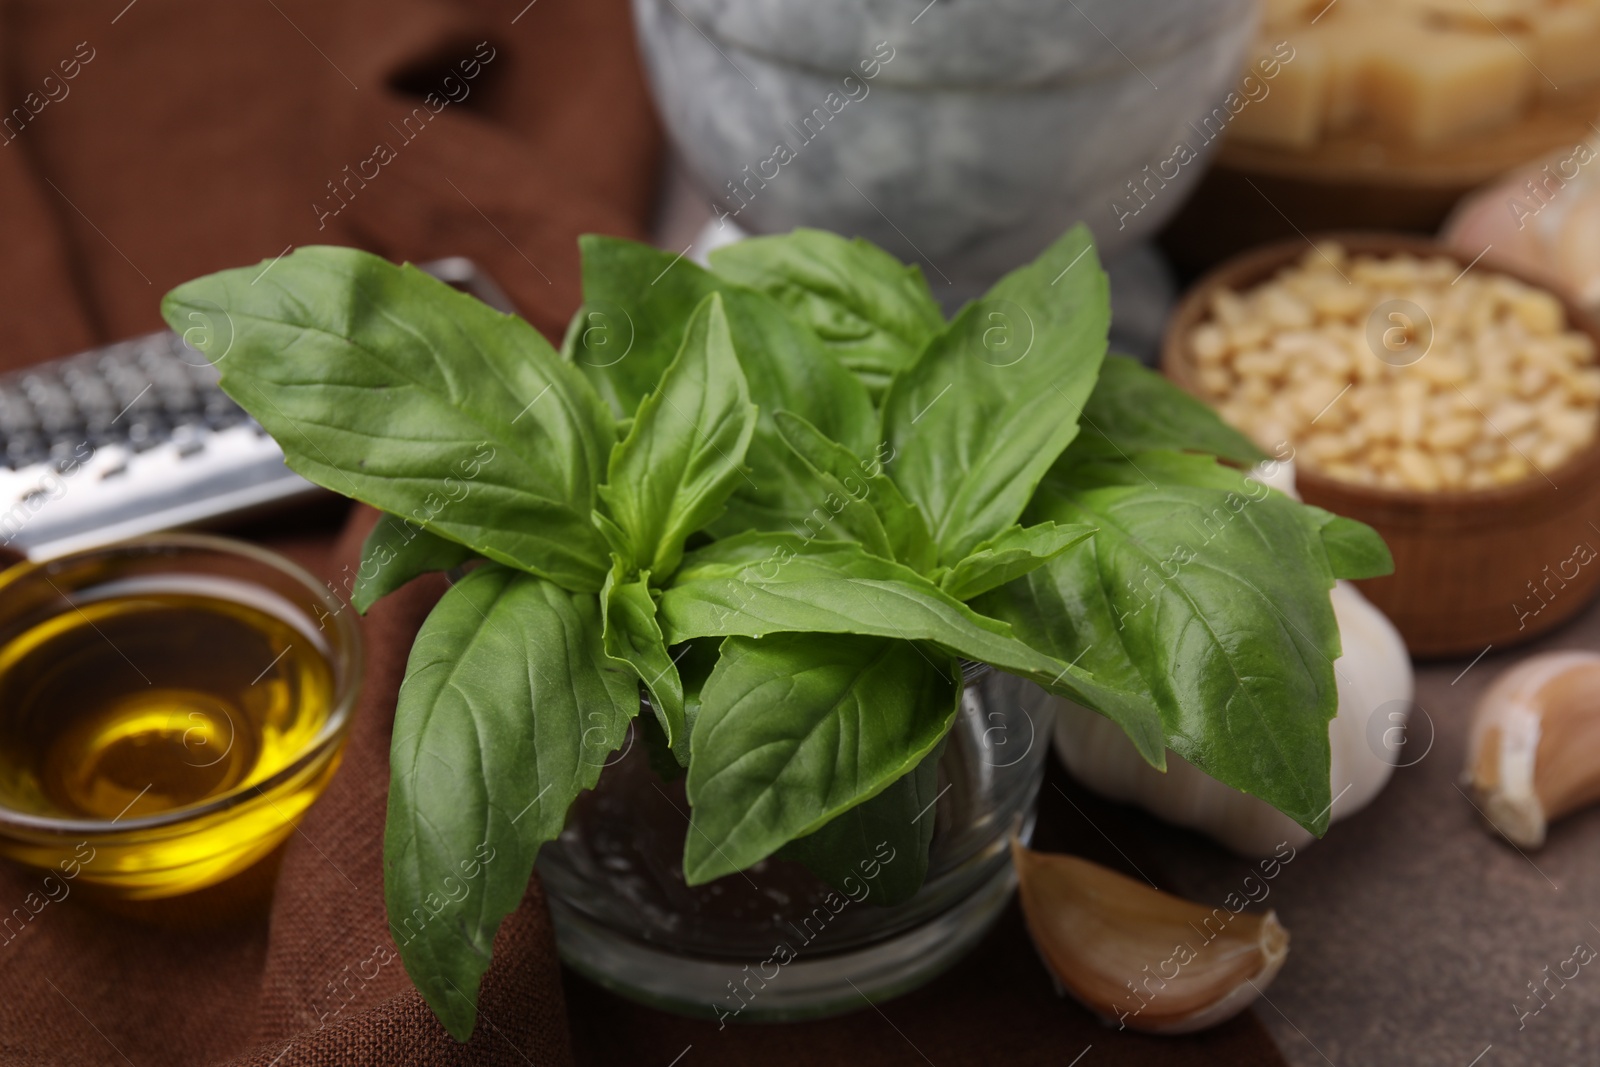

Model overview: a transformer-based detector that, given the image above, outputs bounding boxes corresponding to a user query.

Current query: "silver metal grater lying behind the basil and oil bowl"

[0,258,512,560]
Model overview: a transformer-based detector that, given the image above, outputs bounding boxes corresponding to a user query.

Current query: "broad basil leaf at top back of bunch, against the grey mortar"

[710,229,944,392]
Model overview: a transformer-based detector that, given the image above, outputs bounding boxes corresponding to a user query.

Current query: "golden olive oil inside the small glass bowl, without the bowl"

[0,576,333,821]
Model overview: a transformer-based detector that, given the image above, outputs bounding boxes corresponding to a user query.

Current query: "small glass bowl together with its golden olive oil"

[0,534,360,899]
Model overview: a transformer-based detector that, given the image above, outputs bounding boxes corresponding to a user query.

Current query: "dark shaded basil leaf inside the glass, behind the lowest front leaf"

[778,741,944,907]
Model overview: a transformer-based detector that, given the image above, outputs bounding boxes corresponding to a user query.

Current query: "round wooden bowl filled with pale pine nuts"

[1162,234,1600,656]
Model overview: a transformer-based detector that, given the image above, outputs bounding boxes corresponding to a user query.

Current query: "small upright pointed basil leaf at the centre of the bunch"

[600,293,755,581]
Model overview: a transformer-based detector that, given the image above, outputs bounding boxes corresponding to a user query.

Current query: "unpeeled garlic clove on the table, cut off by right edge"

[1462,653,1600,848]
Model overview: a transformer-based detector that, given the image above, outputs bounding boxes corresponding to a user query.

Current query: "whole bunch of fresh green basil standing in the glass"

[162,226,1389,1040]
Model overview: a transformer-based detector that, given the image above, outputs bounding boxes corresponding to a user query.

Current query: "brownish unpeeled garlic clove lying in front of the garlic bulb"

[1011,840,1290,1033]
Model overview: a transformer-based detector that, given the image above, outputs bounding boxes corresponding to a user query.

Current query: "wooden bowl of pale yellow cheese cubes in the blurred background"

[1168,0,1600,267]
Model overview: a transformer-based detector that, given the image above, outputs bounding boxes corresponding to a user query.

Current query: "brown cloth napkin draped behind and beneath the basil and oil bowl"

[0,0,1282,1067]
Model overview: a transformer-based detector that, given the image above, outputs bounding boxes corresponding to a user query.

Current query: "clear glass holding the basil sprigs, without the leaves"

[539,664,1051,1021]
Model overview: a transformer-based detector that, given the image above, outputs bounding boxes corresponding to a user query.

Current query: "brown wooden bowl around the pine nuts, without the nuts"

[1162,234,1600,656]
